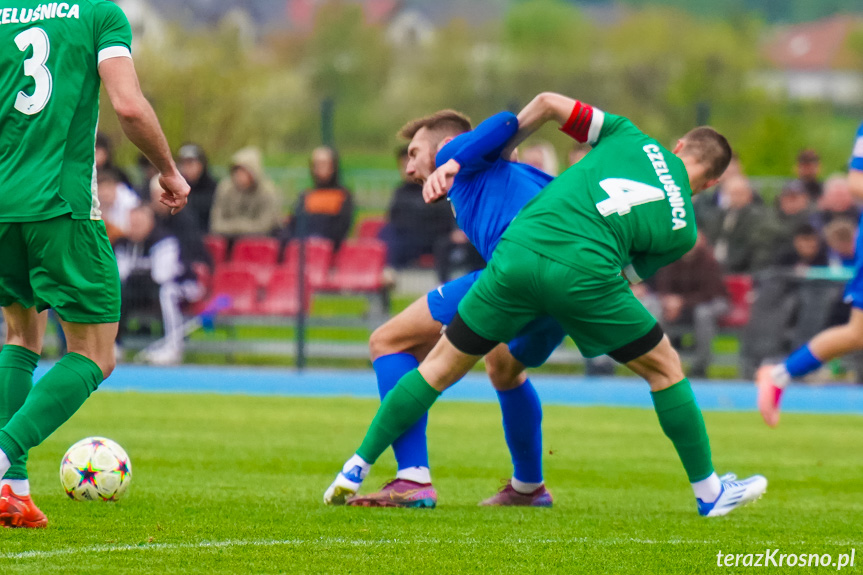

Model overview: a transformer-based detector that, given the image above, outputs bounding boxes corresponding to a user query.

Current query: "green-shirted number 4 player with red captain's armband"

[324,93,767,517]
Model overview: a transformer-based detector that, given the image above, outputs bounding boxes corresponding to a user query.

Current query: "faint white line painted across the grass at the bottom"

[0,537,863,560]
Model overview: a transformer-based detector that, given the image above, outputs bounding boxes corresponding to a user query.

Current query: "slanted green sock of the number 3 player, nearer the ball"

[0,353,104,461]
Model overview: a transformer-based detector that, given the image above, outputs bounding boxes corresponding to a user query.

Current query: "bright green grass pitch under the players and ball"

[0,393,863,575]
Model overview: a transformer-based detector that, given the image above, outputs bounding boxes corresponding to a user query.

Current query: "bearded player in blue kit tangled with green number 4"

[347,110,564,507]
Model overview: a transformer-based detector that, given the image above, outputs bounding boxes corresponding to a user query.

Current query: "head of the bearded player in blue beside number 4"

[399,110,471,183]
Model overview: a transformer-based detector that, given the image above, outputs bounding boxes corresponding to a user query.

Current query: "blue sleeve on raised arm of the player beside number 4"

[435,112,518,173]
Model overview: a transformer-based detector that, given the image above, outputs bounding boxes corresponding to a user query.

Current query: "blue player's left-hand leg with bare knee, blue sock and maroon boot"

[348,292,443,507]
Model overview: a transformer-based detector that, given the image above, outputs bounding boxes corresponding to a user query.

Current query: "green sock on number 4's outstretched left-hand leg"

[357,369,440,463]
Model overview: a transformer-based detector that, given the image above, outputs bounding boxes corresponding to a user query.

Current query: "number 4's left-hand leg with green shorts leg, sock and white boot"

[324,243,536,505]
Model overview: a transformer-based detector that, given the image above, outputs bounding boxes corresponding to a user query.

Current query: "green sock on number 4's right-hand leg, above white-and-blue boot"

[650,379,713,483]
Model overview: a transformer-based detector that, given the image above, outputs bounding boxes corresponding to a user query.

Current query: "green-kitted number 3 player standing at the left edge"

[0,0,189,527]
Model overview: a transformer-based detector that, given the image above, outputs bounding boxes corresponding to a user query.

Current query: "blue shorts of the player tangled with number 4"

[427,270,568,367]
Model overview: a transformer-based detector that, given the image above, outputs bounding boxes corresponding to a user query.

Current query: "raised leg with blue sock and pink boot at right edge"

[755,310,863,427]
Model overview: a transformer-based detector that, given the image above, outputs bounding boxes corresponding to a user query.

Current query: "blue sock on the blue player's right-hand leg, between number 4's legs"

[497,379,542,486]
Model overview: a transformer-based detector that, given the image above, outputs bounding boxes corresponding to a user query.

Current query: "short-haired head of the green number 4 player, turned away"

[673,126,731,194]
